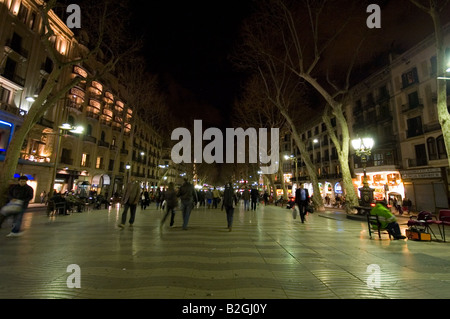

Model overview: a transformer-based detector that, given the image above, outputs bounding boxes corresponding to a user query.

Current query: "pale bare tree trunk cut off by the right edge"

[410,0,450,170]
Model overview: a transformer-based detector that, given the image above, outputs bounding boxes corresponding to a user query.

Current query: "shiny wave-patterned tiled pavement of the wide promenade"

[0,205,450,299]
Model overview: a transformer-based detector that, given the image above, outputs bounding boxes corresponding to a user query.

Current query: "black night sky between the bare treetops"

[133,0,255,127]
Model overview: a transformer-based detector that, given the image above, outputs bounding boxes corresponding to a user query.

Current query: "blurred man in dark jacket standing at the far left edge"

[0,176,34,237]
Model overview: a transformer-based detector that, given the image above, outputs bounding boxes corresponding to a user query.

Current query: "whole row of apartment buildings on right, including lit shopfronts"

[284,25,450,212]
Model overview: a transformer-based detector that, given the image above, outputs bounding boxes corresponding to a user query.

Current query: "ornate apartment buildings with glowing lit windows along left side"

[0,0,162,202]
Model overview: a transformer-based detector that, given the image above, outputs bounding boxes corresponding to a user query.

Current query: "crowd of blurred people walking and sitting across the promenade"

[0,176,412,237]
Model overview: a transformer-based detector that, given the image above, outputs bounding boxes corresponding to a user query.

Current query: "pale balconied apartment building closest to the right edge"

[390,25,450,212]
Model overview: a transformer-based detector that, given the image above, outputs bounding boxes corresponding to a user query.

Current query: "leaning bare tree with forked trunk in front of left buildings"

[0,0,137,204]
